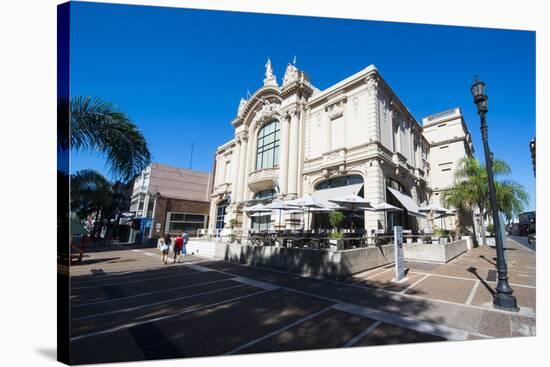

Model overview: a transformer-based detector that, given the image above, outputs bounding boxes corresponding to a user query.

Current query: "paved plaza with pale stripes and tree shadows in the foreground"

[67,240,536,364]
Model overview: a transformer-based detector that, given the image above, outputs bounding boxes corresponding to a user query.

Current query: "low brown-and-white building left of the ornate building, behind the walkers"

[129,163,212,242]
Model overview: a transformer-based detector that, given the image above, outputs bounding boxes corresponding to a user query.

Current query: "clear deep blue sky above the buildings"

[71,2,535,209]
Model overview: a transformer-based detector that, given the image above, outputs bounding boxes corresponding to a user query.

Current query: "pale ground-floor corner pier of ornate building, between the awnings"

[363,159,386,236]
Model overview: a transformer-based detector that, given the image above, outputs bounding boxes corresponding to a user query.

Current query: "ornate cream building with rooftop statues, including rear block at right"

[209,60,472,233]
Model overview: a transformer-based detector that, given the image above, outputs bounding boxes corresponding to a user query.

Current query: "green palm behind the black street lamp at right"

[443,157,529,245]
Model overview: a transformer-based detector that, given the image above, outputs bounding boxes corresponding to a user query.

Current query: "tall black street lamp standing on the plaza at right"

[471,77,519,311]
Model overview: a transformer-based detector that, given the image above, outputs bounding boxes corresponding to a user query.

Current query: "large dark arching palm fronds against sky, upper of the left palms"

[57,96,151,181]
